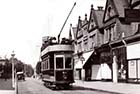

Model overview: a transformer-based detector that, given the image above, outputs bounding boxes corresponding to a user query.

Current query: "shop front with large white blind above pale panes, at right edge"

[127,42,140,83]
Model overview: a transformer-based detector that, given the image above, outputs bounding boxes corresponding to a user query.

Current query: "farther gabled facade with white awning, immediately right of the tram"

[73,5,104,80]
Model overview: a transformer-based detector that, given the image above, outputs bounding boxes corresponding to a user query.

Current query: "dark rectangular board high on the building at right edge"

[125,9,140,22]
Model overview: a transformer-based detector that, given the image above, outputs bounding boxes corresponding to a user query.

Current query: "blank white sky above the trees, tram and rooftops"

[0,0,106,67]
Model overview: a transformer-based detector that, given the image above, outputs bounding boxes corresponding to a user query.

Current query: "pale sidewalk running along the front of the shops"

[73,80,140,94]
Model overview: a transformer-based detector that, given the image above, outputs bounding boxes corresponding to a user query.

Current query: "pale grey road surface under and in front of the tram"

[18,78,119,94]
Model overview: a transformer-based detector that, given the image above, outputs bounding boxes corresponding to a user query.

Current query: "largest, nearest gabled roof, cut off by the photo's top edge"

[103,0,129,22]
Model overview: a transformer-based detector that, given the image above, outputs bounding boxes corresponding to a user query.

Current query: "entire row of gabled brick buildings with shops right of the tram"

[73,0,140,83]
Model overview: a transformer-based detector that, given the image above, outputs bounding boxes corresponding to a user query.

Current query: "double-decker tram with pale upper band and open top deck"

[41,38,74,88]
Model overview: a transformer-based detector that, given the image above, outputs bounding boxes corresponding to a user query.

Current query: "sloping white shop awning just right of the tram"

[74,51,94,69]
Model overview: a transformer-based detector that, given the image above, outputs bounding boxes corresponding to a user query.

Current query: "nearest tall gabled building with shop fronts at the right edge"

[103,0,140,82]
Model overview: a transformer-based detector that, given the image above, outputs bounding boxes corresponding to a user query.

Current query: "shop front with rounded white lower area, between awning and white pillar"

[97,44,112,81]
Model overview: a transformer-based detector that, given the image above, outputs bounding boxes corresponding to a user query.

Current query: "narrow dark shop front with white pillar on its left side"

[112,46,127,82]
